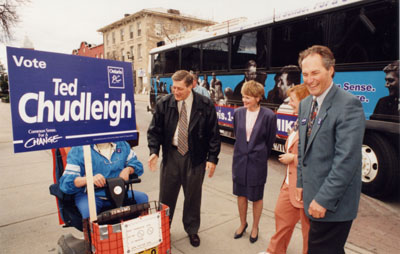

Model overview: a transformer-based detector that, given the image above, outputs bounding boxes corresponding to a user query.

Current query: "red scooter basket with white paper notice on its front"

[90,201,171,254]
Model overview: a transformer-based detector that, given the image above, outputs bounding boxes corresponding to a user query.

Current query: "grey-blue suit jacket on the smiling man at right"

[297,84,365,221]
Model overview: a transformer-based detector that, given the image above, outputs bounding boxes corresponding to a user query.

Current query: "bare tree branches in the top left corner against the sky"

[0,0,29,42]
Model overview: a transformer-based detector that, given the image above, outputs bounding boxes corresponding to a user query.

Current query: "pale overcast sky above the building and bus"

[0,0,327,69]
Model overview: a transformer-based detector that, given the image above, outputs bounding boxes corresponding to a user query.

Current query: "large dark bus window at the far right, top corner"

[331,1,399,63]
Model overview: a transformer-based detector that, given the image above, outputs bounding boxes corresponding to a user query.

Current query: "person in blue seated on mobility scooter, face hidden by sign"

[50,141,148,253]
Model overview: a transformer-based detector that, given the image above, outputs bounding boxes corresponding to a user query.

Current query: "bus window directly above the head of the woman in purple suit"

[231,29,267,69]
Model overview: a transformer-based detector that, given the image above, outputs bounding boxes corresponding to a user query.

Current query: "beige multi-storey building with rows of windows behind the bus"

[98,8,215,93]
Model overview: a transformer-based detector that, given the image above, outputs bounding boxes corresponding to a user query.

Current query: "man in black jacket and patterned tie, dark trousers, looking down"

[147,70,221,247]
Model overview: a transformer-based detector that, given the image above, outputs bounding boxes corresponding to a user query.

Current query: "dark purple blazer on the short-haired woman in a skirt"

[232,107,277,186]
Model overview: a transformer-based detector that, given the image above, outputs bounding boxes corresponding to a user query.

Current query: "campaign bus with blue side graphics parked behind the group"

[149,0,400,197]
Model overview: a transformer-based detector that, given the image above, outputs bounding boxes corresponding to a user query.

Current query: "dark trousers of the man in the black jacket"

[160,148,206,234]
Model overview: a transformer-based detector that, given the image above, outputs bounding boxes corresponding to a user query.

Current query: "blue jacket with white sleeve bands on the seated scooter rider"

[60,141,143,197]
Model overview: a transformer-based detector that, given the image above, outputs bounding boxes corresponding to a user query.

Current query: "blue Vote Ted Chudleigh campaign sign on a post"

[7,47,137,153]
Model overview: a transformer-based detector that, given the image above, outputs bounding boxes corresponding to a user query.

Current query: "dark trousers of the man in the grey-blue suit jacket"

[308,220,353,254]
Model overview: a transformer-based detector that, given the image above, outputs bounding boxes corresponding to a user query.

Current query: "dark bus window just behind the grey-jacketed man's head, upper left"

[271,16,327,67]
